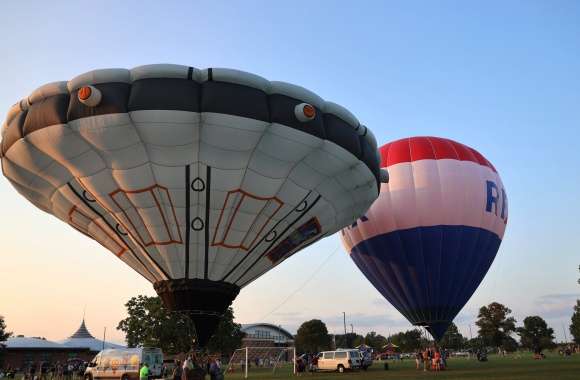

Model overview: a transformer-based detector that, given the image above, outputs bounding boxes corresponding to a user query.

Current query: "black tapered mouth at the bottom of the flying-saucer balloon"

[153,279,240,347]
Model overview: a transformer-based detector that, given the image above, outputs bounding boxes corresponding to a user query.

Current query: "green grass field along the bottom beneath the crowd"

[226,354,580,380]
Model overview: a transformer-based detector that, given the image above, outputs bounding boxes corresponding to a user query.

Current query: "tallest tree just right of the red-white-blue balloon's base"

[475,302,516,348]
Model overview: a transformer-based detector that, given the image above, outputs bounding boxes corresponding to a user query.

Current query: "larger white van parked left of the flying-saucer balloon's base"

[85,347,163,380]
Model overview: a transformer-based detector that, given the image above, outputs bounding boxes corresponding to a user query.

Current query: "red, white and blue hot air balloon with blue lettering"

[341,137,508,340]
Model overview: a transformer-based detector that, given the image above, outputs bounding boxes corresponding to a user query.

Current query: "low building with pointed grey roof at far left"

[2,319,123,370]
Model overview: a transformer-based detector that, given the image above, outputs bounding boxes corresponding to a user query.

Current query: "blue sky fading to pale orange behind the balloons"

[0,0,580,341]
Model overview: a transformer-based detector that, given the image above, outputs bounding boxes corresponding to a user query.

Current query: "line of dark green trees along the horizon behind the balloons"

[0,296,580,359]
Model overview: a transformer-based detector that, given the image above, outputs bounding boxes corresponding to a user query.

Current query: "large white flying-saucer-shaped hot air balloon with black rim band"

[0,64,385,346]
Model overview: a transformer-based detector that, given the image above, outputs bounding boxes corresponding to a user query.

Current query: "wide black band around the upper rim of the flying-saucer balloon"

[10,76,380,187]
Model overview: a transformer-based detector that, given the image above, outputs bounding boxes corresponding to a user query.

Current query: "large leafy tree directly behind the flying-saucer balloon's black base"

[117,296,242,354]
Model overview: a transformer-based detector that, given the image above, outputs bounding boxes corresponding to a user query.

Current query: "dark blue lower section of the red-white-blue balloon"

[350,225,501,339]
